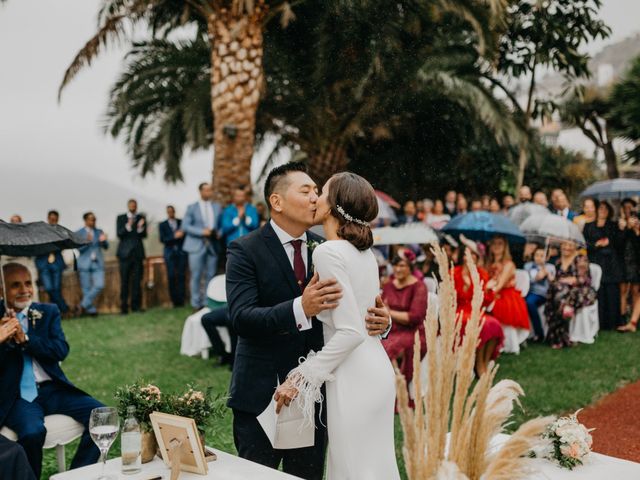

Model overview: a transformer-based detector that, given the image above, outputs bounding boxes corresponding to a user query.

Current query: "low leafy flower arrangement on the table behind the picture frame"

[115,381,226,432]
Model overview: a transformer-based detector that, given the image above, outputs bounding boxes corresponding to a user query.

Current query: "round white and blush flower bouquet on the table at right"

[541,410,593,470]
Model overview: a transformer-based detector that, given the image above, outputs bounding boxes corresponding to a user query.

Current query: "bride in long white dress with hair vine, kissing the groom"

[275,172,400,480]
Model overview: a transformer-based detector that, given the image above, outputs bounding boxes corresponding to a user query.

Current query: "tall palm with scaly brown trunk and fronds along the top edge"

[60,0,292,202]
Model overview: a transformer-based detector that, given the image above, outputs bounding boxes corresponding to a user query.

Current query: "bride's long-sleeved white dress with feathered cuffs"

[294,240,400,480]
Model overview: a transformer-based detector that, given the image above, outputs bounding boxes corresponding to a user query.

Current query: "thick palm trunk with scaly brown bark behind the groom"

[208,4,266,203]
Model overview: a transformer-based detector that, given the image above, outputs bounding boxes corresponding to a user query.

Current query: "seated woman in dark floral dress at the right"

[544,242,596,349]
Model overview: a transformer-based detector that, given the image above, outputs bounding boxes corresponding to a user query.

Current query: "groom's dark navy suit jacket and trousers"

[226,223,326,480]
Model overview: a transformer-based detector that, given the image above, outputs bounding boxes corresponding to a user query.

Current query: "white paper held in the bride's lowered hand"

[258,392,315,450]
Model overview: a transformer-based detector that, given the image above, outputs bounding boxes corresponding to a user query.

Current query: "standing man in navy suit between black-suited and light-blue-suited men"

[158,205,187,307]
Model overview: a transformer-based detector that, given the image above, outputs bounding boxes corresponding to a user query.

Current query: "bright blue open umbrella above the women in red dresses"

[442,212,526,243]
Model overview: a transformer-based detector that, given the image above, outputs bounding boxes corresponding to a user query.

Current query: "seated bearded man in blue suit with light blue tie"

[0,263,103,478]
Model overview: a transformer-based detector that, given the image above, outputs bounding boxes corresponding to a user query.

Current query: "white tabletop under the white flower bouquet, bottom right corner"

[492,435,640,480]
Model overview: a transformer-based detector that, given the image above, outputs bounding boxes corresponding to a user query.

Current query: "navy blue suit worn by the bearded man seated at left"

[0,302,103,478]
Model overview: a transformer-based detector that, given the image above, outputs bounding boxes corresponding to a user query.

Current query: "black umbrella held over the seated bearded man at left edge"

[0,220,88,298]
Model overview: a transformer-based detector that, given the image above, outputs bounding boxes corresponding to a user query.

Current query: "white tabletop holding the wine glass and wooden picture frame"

[50,448,299,480]
